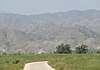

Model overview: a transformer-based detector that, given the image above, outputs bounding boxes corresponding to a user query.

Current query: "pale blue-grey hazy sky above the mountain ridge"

[0,0,100,15]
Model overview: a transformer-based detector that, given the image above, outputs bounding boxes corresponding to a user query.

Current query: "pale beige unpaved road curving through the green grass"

[23,61,55,70]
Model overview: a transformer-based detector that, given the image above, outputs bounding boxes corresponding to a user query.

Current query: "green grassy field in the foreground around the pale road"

[0,54,100,70]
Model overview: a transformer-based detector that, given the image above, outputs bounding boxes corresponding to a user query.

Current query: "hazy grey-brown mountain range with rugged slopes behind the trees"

[0,10,100,53]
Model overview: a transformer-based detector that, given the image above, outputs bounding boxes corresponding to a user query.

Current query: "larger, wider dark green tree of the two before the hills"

[56,43,71,54]
